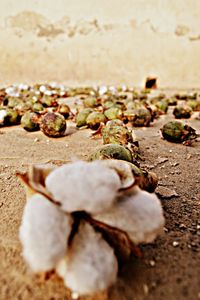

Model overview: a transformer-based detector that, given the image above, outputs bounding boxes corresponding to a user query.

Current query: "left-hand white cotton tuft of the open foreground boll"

[20,194,72,272]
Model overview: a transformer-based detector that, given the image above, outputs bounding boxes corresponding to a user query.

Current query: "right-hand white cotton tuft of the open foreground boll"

[93,187,164,244]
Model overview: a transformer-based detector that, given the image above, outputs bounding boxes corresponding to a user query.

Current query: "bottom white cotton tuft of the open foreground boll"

[56,223,118,295]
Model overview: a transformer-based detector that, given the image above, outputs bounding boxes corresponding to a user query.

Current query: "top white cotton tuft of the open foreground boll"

[45,161,121,213]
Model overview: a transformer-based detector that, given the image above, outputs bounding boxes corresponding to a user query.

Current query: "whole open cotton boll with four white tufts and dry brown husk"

[20,160,164,295]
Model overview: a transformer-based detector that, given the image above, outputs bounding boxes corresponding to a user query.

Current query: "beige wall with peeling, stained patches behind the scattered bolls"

[0,0,200,87]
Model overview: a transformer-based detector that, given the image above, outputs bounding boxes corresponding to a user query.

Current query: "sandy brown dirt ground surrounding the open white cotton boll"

[0,101,200,300]
